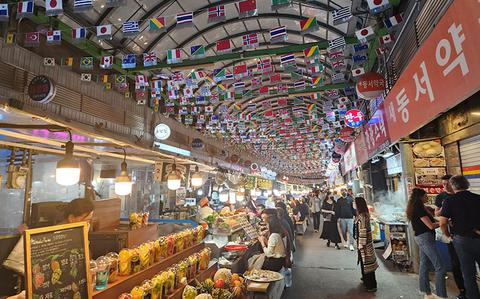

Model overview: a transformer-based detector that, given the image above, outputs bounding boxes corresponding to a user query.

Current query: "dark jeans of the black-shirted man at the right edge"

[453,236,480,299]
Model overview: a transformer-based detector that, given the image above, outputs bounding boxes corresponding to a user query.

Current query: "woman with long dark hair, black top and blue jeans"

[407,188,447,298]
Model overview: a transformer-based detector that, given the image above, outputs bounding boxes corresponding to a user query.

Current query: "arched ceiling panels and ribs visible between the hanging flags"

[53,0,376,176]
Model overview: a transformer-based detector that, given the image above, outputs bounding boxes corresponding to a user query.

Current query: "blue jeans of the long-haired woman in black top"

[415,232,447,298]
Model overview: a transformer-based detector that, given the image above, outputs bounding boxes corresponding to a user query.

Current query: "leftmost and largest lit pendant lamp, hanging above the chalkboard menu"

[55,131,80,186]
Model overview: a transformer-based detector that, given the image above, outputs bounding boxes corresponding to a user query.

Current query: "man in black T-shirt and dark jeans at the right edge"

[440,175,480,299]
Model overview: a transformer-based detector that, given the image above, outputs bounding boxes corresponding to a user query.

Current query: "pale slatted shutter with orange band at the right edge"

[460,136,480,194]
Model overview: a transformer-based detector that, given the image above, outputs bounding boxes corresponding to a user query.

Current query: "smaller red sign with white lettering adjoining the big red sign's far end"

[363,104,390,158]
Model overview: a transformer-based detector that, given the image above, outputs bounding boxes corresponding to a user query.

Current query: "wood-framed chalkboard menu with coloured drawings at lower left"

[25,222,92,299]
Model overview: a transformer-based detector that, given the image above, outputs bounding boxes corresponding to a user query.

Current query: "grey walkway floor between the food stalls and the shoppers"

[282,227,457,299]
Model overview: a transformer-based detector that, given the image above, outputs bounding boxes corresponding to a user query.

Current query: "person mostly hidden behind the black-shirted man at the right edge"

[435,174,466,299]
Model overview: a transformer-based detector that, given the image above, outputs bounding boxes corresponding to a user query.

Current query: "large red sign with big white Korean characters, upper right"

[385,1,480,142]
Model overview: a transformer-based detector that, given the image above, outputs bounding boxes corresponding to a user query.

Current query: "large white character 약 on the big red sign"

[435,23,469,77]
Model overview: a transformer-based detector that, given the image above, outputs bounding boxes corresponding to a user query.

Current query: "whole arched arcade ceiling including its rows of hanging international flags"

[14,0,402,176]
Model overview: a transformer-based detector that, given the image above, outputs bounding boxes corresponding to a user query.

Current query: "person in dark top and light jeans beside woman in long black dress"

[336,189,354,251]
